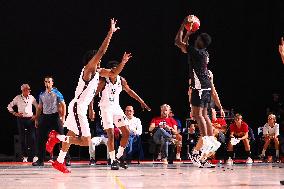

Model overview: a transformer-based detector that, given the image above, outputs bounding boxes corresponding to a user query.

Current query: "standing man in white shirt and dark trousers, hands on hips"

[7,84,37,162]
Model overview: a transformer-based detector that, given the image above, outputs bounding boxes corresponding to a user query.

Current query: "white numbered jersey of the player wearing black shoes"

[99,76,122,107]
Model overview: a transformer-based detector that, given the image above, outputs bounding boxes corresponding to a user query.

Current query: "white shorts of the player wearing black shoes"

[101,106,128,130]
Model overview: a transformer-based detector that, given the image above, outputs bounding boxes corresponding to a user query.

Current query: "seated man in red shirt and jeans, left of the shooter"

[149,104,177,164]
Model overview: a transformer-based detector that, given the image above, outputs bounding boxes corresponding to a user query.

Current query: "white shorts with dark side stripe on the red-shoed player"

[64,102,91,137]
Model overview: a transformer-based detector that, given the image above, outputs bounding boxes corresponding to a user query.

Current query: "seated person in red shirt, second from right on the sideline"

[227,114,252,164]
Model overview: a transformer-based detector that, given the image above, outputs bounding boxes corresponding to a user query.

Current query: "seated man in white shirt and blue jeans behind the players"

[125,106,143,161]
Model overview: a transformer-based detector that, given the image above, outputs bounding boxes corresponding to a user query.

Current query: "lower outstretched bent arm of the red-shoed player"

[99,52,132,77]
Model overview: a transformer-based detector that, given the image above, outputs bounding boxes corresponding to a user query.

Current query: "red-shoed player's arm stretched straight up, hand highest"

[83,19,119,81]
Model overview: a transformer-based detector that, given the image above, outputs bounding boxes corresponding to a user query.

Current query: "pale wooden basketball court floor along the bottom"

[0,162,284,189]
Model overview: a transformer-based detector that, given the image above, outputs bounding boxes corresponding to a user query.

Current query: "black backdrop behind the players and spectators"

[0,0,284,154]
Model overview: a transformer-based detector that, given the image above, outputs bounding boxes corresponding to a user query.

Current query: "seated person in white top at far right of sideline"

[261,114,279,159]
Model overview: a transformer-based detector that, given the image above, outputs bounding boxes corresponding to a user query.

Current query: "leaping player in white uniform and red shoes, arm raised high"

[46,19,131,173]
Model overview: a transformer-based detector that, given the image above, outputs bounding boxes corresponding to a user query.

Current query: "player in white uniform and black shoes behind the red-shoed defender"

[90,61,151,170]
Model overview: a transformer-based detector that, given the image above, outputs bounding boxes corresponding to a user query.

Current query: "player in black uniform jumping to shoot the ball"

[175,17,218,167]
